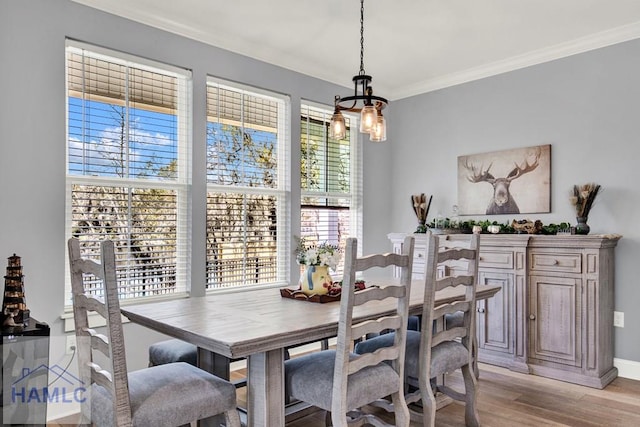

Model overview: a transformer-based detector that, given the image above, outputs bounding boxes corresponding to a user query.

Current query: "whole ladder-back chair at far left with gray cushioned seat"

[68,238,240,427]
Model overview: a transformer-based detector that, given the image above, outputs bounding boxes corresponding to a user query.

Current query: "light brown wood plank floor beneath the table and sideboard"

[50,364,640,427]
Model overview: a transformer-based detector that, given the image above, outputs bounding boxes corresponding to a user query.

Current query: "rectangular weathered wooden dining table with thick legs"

[121,280,500,427]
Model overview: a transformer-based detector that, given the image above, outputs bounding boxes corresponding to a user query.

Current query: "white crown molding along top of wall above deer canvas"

[392,22,640,100]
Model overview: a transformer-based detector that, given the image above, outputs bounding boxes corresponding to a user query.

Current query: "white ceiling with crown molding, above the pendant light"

[73,0,640,100]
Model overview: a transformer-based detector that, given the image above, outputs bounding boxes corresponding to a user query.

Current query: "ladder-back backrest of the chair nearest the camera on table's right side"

[331,236,414,422]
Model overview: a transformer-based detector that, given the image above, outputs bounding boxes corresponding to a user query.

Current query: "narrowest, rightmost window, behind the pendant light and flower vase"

[300,105,362,274]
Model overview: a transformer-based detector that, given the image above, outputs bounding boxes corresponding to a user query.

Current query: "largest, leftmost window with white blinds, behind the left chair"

[66,41,191,305]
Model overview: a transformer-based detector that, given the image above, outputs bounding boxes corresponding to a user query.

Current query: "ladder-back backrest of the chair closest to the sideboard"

[420,232,480,378]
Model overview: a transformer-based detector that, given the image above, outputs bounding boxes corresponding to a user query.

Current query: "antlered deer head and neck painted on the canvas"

[463,147,541,215]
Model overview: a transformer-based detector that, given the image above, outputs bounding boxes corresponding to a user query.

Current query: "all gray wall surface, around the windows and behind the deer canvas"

[0,0,640,384]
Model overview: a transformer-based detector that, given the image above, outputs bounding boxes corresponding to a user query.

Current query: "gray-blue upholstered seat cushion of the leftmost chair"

[90,362,236,427]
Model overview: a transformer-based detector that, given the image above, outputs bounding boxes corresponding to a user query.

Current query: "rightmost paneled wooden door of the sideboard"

[529,275,582,366]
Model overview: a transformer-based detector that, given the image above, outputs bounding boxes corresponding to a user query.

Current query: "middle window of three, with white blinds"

[206,79,290,289]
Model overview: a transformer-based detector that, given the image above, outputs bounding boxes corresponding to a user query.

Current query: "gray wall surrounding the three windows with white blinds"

[0,0,390,369]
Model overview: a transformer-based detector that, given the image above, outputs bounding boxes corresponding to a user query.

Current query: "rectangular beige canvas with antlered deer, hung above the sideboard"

[458,145,551,215]
